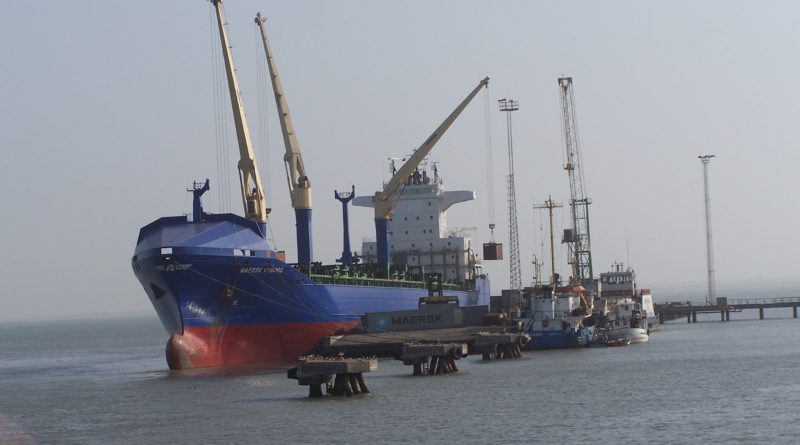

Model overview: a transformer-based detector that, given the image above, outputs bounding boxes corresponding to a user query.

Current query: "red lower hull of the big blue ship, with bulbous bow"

[166,321,358,370]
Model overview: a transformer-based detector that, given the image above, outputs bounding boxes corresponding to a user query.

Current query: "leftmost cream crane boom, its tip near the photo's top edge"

[211,0,270,222]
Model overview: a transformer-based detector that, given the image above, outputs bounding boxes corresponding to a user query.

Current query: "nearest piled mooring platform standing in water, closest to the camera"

[287,356,378,398]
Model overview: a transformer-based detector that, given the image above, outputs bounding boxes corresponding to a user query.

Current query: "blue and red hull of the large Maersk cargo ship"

[132,214,489,369]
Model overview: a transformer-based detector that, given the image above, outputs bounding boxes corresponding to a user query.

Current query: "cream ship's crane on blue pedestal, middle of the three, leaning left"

[255,12,313,264]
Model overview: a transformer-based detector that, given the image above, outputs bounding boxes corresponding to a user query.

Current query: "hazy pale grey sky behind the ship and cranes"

[0,0,800,321]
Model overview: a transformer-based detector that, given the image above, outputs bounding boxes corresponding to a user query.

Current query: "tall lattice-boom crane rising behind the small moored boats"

[558,77,594,284]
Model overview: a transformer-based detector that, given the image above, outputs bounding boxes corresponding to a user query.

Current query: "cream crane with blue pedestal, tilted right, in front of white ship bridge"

[373,77,489,277]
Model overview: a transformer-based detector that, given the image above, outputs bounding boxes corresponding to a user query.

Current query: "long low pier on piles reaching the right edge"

[656,297,800,323]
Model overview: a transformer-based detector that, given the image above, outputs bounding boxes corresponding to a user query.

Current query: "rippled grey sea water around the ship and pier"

[0,309,800,444]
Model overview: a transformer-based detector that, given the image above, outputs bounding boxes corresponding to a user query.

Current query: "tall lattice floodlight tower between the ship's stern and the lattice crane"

[498,99,522,307]
